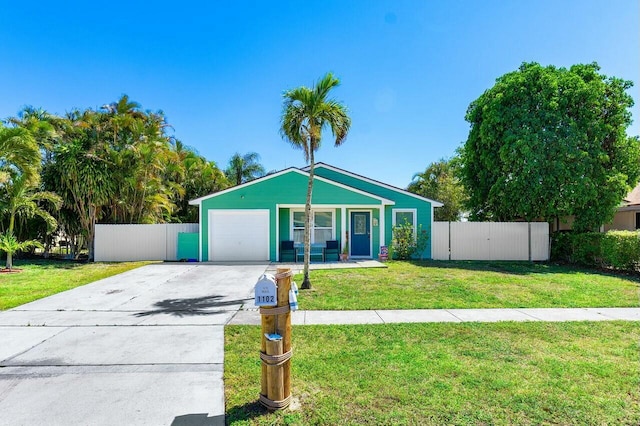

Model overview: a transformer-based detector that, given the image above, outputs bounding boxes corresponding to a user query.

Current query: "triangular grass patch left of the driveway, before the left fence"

[0,260,151,310]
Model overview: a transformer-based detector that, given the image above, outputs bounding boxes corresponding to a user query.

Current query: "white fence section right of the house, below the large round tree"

[431,222,549,261]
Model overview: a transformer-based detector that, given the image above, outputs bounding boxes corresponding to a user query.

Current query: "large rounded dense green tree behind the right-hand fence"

[461,63,640,230]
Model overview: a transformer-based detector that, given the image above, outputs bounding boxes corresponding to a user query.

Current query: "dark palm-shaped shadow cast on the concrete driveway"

[135,295,252,317]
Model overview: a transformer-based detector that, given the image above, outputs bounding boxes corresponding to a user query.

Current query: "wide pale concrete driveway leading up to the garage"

[0,264,268,426]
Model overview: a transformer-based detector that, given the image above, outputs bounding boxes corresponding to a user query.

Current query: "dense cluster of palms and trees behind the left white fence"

[0,95,229,258]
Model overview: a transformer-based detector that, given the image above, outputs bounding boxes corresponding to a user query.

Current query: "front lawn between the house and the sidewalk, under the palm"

[295,261,640,310]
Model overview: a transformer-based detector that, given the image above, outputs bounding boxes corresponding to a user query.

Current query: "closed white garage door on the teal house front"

[209,210,269,262]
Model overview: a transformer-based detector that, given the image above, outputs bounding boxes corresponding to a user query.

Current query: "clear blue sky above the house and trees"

[0,0,640,187]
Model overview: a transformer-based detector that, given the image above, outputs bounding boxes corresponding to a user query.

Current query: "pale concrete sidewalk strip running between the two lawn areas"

[228,308,640,325]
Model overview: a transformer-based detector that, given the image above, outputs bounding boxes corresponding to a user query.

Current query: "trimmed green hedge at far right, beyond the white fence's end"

[551,231,640,271]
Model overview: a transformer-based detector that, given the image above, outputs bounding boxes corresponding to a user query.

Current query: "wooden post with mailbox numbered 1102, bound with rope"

[255,268,293,410]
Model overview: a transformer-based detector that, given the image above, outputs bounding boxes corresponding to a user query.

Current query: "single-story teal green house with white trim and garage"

[189,163,442,262]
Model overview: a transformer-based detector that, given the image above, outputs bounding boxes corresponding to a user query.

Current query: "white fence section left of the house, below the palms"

[94,223,199,262]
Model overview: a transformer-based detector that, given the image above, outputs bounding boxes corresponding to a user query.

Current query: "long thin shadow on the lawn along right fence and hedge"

[407,260,640,282]
